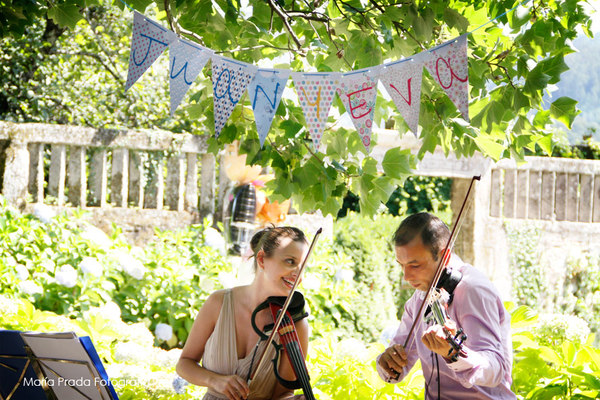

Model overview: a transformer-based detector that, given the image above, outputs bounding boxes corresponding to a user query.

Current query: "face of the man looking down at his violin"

[394,235,439,292]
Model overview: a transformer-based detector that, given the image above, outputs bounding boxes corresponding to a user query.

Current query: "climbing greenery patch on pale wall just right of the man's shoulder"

[504,222,546,309]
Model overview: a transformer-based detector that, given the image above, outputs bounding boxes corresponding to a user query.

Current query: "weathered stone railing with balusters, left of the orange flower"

[0,121,230,241]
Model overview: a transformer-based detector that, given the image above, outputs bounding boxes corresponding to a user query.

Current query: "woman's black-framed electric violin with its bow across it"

[248,228,322,400]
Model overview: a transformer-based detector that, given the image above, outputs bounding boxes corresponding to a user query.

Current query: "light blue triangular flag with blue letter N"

[248,69,290,147]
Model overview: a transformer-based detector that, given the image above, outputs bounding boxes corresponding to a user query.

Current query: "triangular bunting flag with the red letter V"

[379,53,423,135]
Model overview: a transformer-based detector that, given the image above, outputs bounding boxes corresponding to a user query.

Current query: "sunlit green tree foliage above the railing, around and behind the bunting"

[0,0,591,219]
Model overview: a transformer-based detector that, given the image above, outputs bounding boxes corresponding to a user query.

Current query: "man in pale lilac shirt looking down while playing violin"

[377,213,516,400]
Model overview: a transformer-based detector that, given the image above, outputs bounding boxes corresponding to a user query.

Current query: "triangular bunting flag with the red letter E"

[337,68,379,151]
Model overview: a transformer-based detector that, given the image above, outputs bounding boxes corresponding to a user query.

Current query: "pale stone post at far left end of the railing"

[2,139,29,209]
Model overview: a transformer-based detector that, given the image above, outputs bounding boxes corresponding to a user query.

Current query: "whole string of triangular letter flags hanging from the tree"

[125,11,469,151]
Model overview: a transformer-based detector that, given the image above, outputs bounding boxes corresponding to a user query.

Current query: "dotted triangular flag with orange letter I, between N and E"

[292,72,341,149]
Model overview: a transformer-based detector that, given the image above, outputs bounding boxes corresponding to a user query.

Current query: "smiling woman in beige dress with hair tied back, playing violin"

[177,226,308,400]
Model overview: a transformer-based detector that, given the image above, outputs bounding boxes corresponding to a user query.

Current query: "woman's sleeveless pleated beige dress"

[202,289,278,400]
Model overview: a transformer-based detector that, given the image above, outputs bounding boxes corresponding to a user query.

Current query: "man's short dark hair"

[393,212,450,261]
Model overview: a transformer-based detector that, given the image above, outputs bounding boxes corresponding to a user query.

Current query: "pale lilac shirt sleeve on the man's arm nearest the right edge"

[447,285,512,387]
